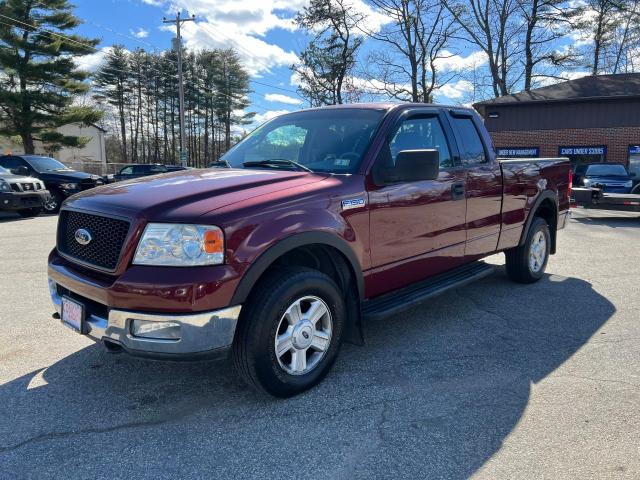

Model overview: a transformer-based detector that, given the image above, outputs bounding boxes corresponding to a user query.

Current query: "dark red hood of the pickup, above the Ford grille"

[65,168,327,221]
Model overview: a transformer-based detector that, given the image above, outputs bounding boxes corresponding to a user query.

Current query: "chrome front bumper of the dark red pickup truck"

[49,279,241,360]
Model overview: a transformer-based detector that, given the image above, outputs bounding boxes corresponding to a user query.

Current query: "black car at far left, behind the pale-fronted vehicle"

[0,155,104,213]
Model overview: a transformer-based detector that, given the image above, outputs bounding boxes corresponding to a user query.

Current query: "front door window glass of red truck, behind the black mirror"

[389,117,453,168]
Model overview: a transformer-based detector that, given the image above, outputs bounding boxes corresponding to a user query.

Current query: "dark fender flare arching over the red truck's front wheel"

[230,232,364,305]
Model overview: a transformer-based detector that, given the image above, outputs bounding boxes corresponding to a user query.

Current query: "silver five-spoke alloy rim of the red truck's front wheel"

[274,296,333,375]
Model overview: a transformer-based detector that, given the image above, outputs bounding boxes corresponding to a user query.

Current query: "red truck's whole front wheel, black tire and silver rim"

[232,267,346,398]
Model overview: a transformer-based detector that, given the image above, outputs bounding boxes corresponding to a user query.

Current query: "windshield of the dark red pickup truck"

[221,108,385,173]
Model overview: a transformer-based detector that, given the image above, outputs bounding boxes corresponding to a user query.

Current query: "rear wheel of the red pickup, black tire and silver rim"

[505,217,551,283]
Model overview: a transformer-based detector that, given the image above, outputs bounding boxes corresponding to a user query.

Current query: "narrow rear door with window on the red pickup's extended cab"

[450,110,502,257]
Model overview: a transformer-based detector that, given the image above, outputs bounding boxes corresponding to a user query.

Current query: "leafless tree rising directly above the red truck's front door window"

[361,0,456,102]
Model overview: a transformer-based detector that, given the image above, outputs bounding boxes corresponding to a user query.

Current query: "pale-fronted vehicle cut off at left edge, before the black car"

[0,167,49,217]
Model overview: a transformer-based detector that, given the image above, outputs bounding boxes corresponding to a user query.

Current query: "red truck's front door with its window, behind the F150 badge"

[367,113,466,296]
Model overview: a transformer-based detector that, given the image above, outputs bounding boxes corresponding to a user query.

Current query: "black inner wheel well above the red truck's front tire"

[256,244,364,345]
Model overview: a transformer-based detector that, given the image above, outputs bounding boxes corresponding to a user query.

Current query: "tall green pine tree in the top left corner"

[0,0,101,153]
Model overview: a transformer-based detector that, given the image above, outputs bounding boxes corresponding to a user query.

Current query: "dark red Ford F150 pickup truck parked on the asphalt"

[48,104,571,397]
